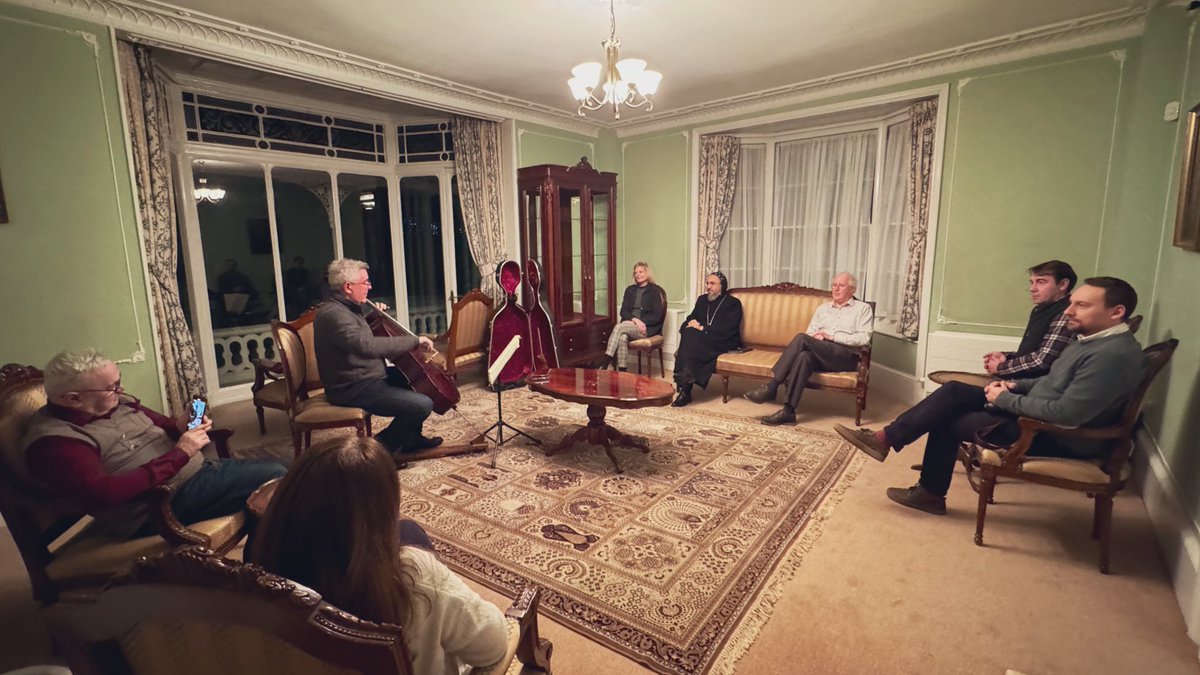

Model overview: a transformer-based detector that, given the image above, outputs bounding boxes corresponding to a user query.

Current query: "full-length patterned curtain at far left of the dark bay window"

[116,42,208,416]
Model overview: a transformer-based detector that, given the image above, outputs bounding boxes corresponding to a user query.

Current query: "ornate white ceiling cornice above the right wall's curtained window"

[608,4,1150,138]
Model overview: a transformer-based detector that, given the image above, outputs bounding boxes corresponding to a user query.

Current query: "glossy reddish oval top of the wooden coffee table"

[527,368,674,408]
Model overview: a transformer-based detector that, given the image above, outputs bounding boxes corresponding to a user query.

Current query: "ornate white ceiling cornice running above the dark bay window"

[8,0,600,137]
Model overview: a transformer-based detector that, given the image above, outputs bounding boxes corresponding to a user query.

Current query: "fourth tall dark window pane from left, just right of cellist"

[400,175,446,334]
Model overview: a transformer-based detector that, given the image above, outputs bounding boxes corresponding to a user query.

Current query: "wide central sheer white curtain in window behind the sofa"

[767,130,878,288]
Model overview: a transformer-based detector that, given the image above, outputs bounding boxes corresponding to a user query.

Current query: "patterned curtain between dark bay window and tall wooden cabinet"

[450,115,508,300]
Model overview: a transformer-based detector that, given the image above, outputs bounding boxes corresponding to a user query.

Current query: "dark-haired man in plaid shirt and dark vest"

[983,261,1078,380]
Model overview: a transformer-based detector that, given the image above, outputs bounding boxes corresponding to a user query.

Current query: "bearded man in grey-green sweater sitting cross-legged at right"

[835,276,1145,515]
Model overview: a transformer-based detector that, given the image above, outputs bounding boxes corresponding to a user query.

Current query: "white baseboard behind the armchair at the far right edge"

[1133,429,1200,645]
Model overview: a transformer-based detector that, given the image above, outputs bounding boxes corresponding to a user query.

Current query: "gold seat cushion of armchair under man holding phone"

[46,512,246,580]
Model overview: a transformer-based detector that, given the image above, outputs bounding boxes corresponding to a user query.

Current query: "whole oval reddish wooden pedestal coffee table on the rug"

[528,368,674,473]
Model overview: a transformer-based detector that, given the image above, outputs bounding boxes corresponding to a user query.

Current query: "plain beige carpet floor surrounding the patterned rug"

[0,380,1200,675]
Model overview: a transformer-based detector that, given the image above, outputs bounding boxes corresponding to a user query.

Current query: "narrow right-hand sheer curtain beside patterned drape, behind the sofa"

[858,120,912,330]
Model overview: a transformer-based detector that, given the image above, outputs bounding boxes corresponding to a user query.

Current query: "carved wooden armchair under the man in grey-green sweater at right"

[964,340,1180,574]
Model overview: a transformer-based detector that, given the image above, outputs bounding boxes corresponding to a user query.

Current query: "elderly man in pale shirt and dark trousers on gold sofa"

[746,271,875,424]
